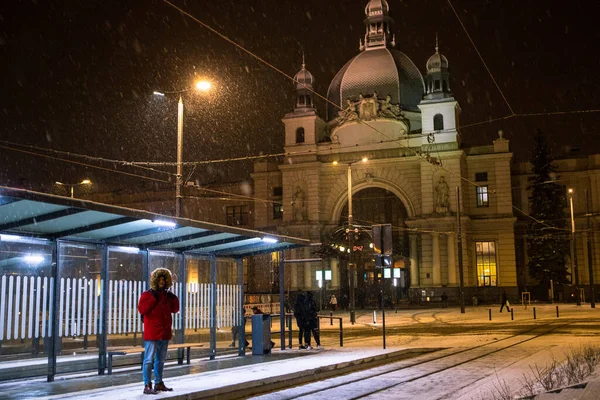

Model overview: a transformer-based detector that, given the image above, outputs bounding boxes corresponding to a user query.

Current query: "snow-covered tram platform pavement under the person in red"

[0,348,427,400]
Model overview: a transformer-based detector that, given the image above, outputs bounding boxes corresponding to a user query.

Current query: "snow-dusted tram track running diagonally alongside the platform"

[253,321,573,400]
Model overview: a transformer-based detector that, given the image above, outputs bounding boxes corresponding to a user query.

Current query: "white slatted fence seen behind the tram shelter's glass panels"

[0,275,241,341]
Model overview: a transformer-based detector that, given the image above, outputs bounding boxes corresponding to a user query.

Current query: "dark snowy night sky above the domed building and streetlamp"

[0,0,600,191]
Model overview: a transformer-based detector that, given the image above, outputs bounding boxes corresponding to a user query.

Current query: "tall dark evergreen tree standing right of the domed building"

[527,130,570,284]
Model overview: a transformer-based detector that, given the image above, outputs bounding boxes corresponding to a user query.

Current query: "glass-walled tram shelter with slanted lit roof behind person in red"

[0,186,310,381]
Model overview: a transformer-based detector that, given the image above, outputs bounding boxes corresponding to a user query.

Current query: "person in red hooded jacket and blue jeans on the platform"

[138,268,179,394]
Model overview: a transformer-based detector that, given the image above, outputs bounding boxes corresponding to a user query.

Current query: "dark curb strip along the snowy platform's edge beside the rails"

[169,349,438,400]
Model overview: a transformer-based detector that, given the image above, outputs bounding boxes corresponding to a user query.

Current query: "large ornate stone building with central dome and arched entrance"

[250,0,517,307]
